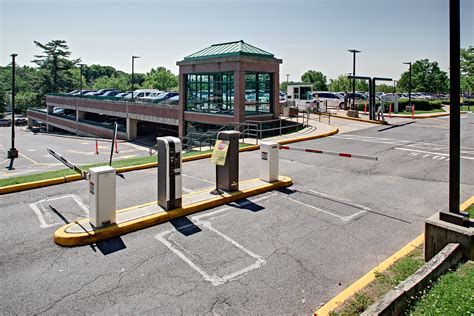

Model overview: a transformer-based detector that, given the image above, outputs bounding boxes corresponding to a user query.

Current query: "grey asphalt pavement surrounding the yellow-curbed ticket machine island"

[0,114,474,314]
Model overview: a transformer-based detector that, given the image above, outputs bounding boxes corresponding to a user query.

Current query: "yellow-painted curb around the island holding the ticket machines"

[54,176,293,247]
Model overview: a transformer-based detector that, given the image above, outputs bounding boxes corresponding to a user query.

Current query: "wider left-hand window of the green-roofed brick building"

[185,73,234,115]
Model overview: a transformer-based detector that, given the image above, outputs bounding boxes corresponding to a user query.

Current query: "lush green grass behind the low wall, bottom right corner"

[407,261,474,315]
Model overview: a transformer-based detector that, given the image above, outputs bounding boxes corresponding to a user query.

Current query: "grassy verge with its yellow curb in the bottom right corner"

[314,196,474,316]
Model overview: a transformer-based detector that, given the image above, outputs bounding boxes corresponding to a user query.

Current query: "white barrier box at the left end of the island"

[89,166,116,228]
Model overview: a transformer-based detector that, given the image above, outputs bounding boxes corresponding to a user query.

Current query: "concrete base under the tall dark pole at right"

[425,213,474,261]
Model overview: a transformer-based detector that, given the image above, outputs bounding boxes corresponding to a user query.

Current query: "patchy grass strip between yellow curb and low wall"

[329,247,425,316]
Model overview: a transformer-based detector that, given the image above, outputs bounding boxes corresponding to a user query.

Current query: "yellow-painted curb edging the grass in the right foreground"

[314,196,474,316]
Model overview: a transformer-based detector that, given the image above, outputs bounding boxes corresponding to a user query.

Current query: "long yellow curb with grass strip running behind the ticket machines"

[0,127,339,195]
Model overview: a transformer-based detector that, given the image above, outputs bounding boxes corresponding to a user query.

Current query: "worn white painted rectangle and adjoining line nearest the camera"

[155,193,277,286]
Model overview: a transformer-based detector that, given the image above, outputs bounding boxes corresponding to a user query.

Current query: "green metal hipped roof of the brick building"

[184,41,274,60]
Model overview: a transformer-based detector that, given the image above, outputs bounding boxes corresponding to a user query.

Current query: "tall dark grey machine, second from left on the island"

[156,136,183,210]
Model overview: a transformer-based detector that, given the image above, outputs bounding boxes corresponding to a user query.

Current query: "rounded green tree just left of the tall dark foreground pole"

[397,59,449,93]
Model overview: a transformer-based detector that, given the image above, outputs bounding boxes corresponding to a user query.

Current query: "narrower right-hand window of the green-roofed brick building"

[245,72,273,115]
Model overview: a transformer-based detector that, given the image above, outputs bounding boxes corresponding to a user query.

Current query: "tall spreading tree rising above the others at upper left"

[32,40,81,94]
